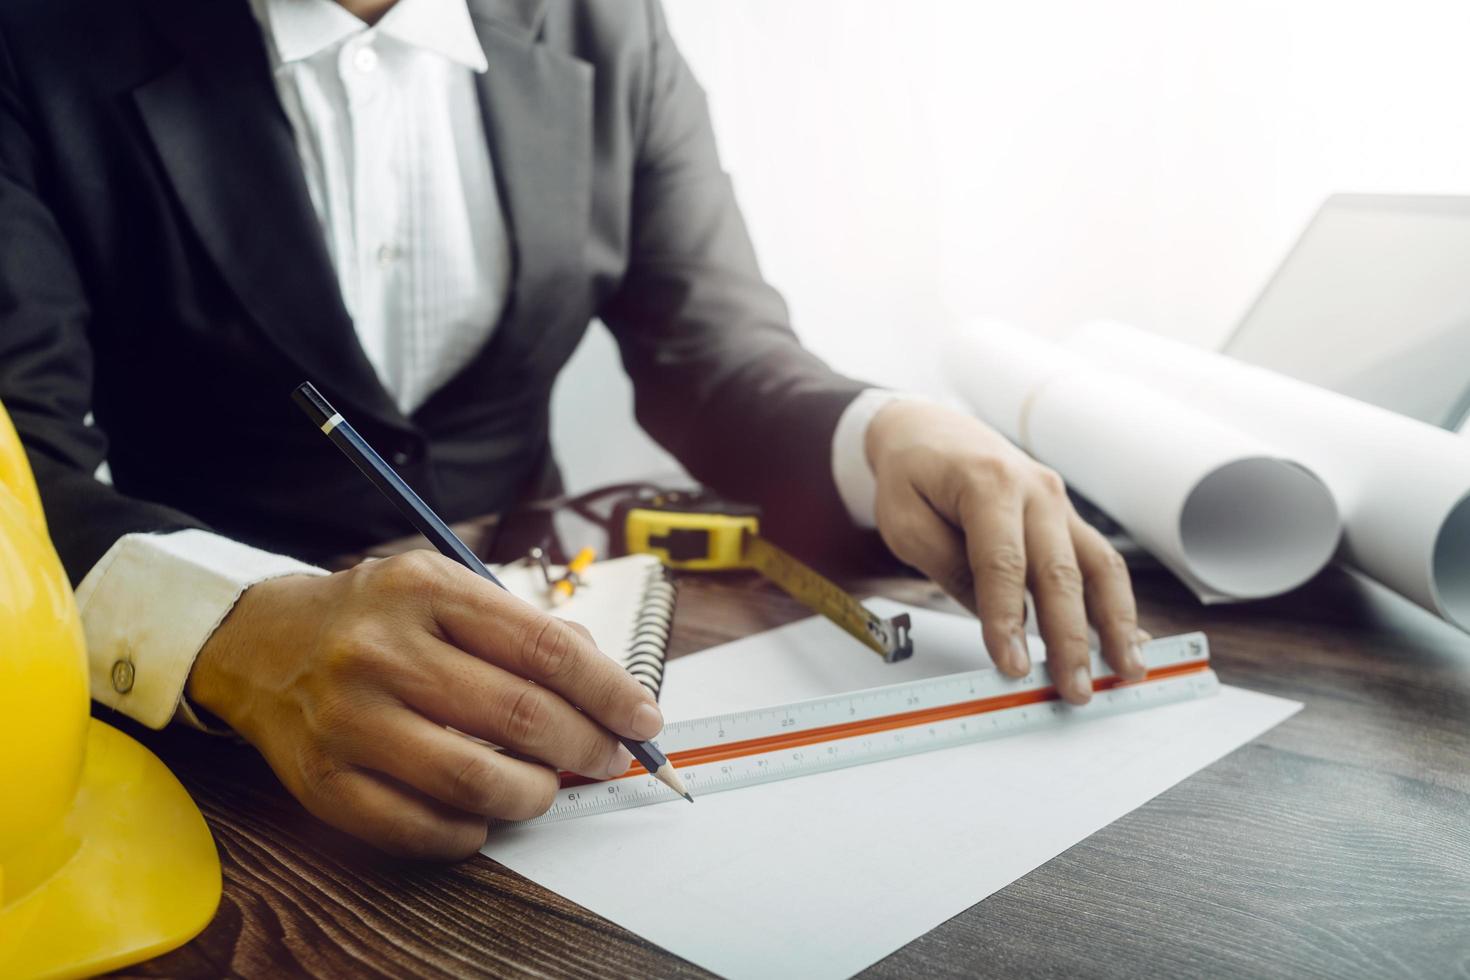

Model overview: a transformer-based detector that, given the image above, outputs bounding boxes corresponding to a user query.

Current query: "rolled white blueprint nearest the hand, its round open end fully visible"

[948,322,1342,602]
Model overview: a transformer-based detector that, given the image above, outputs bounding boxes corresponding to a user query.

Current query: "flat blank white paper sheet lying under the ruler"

[484,602,1301,980]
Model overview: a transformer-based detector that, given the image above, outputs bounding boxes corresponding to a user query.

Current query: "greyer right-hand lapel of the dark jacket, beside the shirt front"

[469,0,592,370]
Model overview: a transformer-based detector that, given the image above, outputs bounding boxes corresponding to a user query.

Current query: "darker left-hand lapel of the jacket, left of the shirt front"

[134,0,406,426]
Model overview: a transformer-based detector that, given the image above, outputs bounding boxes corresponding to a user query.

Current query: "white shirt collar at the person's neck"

[250,0,488,72]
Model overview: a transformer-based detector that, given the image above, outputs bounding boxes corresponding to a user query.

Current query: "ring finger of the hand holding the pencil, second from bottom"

[348,708,559,820]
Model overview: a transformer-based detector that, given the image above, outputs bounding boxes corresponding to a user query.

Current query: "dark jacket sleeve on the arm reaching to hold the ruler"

[600,0,867,547]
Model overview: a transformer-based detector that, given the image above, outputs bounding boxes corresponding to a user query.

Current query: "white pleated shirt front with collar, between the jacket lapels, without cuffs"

[263,0,510,414]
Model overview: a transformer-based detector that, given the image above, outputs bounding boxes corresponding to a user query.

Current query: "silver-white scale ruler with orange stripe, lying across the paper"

[520,633,1220,826]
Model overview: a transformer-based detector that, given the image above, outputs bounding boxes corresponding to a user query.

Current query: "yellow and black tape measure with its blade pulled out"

[619,491,914,663]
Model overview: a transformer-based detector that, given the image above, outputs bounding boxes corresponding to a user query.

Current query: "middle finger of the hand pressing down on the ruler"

[1026,492,1092,704]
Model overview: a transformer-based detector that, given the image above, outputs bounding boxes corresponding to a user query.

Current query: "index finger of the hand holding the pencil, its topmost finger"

[432,569,663,739]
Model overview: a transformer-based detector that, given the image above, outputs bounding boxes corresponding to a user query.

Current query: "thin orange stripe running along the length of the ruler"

[562,660,1210,789]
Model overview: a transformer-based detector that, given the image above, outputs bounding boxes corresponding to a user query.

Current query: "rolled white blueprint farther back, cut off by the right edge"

[1069,322,1470,630]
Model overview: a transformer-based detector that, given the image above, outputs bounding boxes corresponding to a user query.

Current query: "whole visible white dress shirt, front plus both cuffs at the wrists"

[76,0,895,727]
